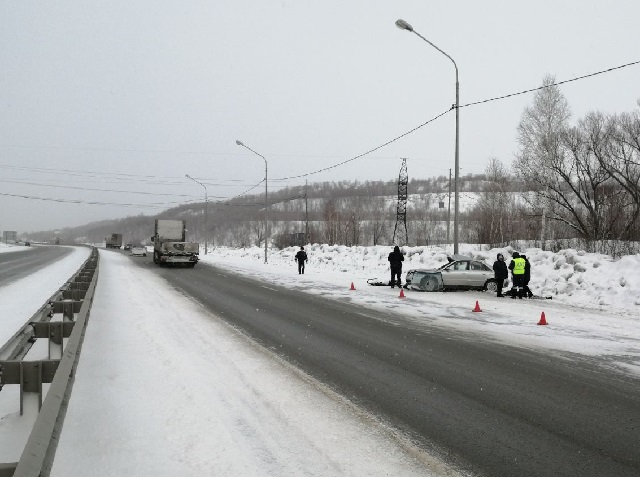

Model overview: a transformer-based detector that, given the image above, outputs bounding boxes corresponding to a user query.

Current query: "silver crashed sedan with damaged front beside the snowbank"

[405,255,497,292]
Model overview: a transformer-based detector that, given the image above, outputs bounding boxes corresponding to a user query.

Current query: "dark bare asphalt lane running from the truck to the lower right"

[140,257,640,477]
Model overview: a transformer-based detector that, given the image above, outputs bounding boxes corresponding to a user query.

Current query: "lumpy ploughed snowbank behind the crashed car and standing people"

[208,244,640,314]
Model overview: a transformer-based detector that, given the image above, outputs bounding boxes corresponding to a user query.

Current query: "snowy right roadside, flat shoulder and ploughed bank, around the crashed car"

[200,244,640,374]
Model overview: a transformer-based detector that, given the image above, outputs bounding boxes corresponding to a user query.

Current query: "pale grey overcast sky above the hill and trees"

[0,0,640,232]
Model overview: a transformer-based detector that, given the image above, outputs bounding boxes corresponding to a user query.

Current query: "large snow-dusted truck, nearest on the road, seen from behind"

[151,220,200,268]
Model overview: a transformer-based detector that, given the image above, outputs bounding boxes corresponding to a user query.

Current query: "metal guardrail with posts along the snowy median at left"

[0,248,99,477]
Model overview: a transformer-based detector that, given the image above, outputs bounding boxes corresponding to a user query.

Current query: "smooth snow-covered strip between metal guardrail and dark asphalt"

[51,251,454,477]
